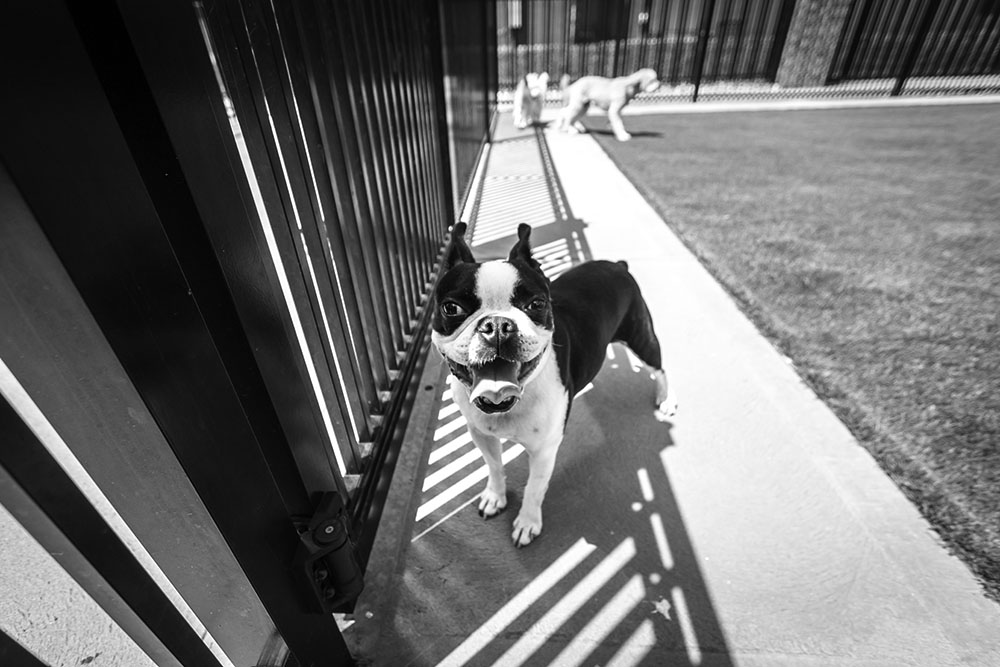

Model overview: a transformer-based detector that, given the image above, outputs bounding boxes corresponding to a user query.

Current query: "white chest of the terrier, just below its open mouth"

[448,355,568,452]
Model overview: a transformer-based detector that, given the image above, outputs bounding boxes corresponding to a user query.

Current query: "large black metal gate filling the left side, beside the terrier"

[0,0,495,667]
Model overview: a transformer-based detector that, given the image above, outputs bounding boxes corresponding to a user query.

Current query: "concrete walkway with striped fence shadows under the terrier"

[345,116,1000,667]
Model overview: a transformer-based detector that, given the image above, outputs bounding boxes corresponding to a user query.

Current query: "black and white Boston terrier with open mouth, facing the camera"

[431,223,676,546]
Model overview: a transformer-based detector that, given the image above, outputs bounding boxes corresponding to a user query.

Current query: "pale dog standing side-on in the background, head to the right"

[557,68,660,141]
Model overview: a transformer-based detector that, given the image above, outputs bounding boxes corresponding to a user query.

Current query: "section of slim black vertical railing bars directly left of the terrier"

[199,1,462,563]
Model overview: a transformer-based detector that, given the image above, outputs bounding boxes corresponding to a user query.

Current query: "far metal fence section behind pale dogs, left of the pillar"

[497,0,794,96]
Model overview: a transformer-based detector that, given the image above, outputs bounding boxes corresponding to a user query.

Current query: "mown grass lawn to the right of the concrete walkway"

[586,104,1000,600]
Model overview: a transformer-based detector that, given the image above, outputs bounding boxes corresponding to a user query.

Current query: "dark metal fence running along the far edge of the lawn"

[497,0,1000,102]
